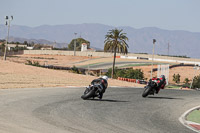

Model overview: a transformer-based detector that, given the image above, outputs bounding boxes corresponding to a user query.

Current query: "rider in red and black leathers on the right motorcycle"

[152,75,166,94]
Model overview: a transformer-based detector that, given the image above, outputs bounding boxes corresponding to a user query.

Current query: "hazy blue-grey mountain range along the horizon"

[0,24,200,58]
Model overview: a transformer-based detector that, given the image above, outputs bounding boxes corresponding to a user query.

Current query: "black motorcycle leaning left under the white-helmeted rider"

[81,85,101,100]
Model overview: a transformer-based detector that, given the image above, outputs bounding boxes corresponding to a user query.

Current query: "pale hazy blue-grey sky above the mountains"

[0,0,200,32]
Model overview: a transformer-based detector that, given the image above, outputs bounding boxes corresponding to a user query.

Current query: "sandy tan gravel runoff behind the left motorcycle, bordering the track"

[0,60,144,89]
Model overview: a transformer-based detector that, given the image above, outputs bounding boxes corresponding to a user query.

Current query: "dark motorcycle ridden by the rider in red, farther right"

[142,79,157,97]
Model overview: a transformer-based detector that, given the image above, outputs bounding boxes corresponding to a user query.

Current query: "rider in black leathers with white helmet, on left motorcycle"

[91,76,108,99]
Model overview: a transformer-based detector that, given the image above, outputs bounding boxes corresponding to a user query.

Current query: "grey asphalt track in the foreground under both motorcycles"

[0,88,200,133]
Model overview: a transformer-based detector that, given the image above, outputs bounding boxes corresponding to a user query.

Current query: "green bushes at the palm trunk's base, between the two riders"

[106,68,144,79]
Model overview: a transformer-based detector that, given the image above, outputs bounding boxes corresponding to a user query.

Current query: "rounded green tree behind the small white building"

[68,38,90,51]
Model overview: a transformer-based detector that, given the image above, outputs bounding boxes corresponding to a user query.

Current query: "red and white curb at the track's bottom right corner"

[179,106,200,133]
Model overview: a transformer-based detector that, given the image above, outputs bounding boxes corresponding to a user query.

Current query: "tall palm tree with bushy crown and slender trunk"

[104,29,128,78]
